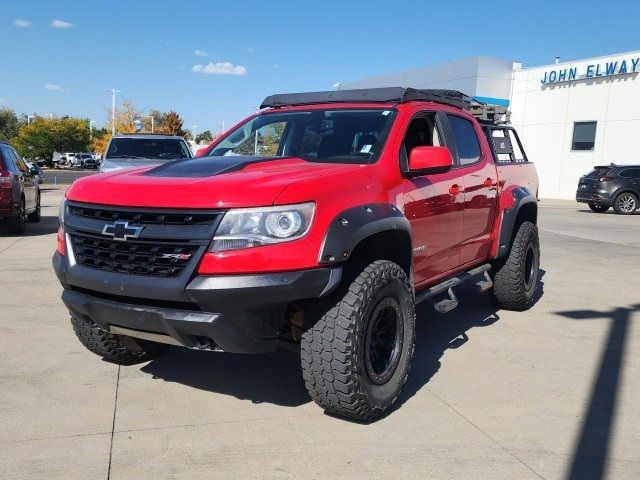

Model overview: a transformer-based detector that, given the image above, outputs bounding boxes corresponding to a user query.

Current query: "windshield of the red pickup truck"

[206,108,395,163]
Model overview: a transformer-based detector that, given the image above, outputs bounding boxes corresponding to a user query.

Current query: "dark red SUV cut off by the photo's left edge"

[0,141,40,234]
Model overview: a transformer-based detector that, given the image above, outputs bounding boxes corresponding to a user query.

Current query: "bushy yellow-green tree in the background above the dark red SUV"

[13,117,89,160]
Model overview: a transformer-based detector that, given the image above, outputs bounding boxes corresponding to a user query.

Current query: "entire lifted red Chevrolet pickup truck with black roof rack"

[53,88,540,420]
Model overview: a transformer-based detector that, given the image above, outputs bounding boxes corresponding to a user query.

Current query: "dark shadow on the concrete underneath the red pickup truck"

[141,270,544,413]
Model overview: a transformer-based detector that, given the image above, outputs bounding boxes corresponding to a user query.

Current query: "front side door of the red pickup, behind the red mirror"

[399,111,464,286]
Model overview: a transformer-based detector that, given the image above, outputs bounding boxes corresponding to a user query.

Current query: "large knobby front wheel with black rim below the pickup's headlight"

[301,260,415,420]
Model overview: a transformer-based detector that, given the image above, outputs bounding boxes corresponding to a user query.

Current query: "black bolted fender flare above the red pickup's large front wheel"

[318,203,411,264]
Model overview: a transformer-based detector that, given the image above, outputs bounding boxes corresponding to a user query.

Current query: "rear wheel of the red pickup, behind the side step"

[493,222,540,310]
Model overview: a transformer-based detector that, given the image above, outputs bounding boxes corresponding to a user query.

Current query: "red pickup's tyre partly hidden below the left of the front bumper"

[71,316,167,365]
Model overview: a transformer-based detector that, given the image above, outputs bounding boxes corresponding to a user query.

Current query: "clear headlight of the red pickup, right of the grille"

[210,202,315,252]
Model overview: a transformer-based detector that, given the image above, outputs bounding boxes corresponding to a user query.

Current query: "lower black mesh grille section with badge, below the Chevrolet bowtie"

[71,233,198,277]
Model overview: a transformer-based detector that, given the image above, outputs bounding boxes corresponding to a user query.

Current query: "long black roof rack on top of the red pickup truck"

[260,87,509,123]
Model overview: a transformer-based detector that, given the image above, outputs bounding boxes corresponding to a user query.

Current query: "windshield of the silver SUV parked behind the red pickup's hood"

[107,138,191,160]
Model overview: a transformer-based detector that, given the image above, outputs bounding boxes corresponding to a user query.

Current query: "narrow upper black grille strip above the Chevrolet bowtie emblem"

[69,205,220,225]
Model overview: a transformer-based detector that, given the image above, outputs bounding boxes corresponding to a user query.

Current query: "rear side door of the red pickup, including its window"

[446,113,498,265]
